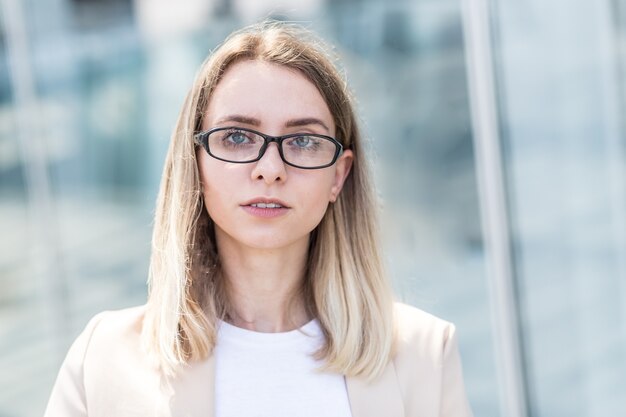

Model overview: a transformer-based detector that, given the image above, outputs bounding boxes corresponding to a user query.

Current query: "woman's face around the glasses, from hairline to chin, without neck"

[197,61,353,249]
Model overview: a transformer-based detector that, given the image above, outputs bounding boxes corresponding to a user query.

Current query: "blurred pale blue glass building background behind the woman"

[0,0,626,417]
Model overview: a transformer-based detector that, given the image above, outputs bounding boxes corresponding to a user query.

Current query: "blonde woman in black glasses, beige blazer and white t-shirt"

[46,23,471,417]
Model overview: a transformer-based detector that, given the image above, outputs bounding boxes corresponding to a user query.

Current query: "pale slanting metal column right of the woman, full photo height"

[461,0,529,417]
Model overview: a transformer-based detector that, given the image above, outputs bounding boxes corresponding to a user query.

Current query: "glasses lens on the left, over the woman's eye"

[208,129,264,162]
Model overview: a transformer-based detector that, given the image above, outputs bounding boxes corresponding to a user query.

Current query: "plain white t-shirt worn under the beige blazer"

[215,320,352,417]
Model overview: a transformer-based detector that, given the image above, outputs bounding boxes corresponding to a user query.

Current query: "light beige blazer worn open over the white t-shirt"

[45,304,472,417]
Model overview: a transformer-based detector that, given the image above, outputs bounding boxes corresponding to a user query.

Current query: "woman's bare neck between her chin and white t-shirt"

[216,228,312,333]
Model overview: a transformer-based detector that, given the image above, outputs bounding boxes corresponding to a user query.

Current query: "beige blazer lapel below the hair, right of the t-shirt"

[346,361,404,417]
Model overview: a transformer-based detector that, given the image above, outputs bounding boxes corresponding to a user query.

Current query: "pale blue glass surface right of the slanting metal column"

[494,0,626,417]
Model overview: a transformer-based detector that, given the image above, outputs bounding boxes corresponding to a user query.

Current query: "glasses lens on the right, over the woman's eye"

[283,135,337,168]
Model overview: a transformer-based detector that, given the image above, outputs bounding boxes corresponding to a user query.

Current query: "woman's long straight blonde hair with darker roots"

[143,22,394,378]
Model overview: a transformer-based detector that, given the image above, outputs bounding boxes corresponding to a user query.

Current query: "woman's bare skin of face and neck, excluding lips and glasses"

[197,61,353,332]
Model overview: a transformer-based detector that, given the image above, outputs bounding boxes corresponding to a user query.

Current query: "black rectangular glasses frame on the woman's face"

[194,126,343,169]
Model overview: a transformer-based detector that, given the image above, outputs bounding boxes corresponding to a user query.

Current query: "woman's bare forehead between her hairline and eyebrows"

[203,61,335,134]
